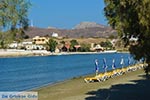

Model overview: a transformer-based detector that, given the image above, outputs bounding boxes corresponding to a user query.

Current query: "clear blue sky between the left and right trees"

[29,0,107,29]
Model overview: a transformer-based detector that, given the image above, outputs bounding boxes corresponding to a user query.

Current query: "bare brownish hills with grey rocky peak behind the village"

[26,22,117,38]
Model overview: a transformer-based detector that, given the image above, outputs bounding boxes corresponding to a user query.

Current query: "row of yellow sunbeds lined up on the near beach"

[84,63,147,83]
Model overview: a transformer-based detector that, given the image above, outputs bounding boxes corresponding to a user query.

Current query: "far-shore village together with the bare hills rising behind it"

[0,22,136,56]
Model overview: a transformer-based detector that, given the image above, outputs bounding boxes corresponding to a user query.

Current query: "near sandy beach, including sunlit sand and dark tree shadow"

[34,69,150,100]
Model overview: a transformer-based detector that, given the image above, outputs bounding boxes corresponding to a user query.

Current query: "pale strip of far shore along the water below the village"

[0,49,119,58]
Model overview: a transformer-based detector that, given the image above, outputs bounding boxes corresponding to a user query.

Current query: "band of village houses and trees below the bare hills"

[4,32,137,53]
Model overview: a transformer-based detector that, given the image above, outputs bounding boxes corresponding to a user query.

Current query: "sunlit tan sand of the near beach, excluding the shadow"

[33,69,148,100]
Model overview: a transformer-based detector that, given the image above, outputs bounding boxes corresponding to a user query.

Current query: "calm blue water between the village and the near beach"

[0,53,130,91]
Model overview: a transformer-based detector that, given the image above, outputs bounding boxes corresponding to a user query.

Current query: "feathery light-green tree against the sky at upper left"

[0,0,30,44]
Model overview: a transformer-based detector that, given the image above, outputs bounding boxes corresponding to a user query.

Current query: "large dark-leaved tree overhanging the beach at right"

[104,0,150,72]
